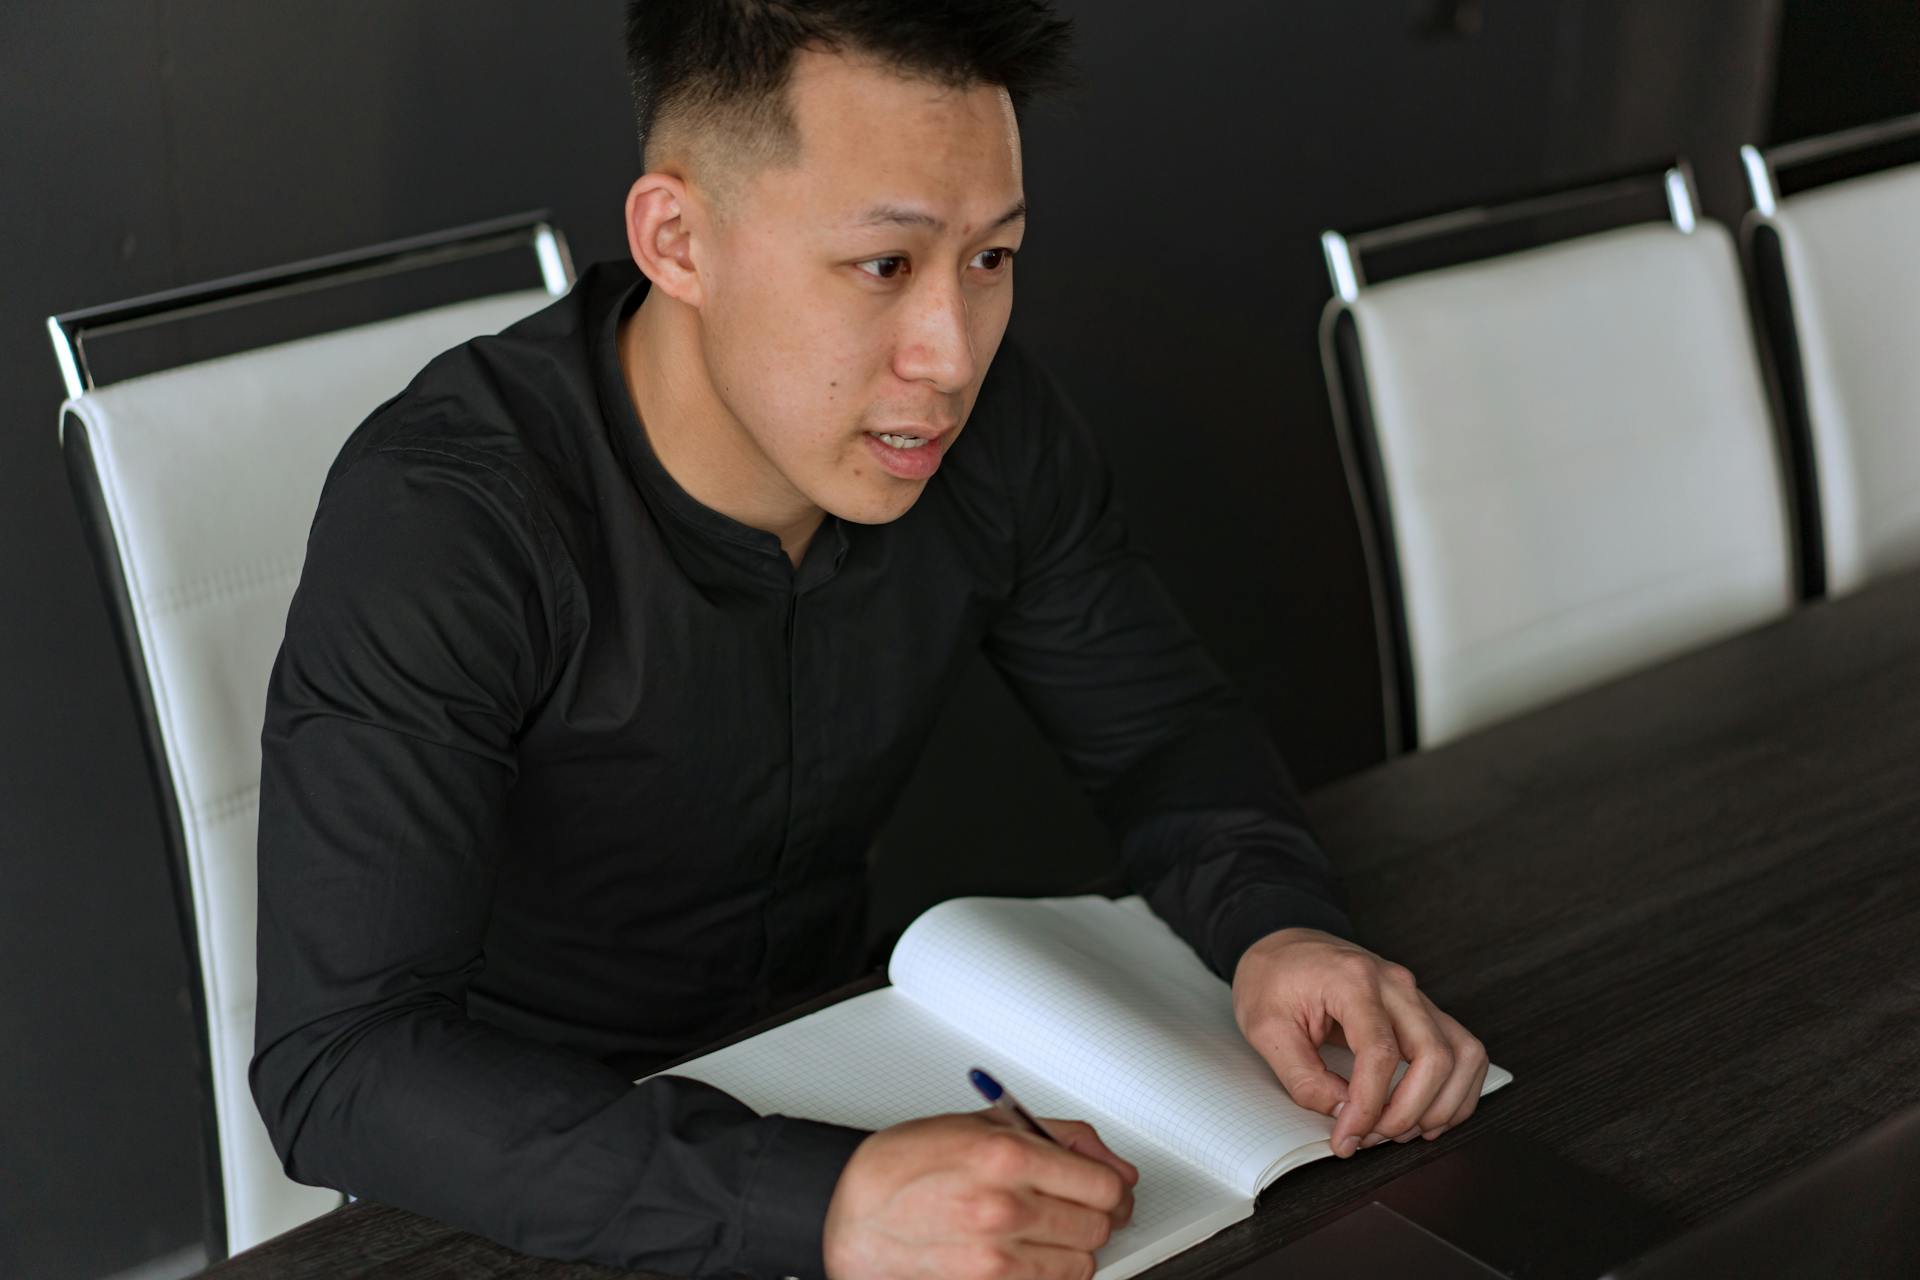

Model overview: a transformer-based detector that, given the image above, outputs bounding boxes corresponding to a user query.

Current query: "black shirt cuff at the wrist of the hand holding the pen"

[733,1115,868,1280]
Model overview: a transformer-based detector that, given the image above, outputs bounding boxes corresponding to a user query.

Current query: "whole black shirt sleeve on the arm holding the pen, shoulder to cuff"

[250,439,864,1274]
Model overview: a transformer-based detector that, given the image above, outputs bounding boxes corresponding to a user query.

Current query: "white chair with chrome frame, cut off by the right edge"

[1741,115,1920,595]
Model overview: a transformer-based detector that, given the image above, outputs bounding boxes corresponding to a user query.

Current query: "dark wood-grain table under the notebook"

[209,576,1920,1280]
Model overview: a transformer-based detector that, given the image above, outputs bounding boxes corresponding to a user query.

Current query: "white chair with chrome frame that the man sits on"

[48,215,572,1261]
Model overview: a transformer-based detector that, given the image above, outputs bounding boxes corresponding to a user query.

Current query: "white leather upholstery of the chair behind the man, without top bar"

[61,290,551,1253]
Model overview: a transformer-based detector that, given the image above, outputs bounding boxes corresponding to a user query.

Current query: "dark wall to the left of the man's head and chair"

[0,0,634,1280]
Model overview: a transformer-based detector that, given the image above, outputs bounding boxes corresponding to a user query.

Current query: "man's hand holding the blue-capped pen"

[822,1111,1140,1280]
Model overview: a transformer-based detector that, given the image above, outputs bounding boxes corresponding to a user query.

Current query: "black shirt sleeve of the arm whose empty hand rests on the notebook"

[987,363,1350,977]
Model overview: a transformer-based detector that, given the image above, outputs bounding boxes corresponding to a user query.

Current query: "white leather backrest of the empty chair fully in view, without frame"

[1336,223,1793,747]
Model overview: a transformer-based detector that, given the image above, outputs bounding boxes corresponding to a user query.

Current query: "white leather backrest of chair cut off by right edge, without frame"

[1770,165,1920,595]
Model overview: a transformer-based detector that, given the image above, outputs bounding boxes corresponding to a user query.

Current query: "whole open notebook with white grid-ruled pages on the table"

[664,896,1513,1280]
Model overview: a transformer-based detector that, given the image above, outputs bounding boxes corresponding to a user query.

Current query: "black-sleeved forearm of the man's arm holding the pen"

[252,1006,864,1274]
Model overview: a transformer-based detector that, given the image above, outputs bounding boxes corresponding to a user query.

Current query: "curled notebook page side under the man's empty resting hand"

[889,896,1511,1196]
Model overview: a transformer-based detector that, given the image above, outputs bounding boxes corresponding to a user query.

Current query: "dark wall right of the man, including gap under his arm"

[876,0,1778,929]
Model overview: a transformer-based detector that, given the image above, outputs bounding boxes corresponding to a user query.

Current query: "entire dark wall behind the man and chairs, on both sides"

[0,0,1920,1278]
